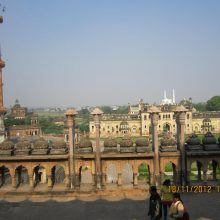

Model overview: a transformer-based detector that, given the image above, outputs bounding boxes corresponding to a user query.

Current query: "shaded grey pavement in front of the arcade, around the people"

[0,193,220,220]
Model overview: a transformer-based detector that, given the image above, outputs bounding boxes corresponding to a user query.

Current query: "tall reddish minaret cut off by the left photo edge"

[0,16,6,143]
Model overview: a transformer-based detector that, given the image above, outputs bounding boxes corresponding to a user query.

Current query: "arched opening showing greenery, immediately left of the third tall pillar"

[138,163,150,185]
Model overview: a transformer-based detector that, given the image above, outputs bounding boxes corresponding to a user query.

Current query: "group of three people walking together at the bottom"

[148,179,189,220]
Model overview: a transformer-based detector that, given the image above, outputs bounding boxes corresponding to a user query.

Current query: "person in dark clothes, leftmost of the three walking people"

[148,186,162,220]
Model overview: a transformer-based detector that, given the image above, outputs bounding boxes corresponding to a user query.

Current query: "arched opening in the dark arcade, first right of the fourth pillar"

[190,160,203,184]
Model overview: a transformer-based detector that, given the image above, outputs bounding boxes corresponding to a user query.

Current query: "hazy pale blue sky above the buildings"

[0,0,220,107]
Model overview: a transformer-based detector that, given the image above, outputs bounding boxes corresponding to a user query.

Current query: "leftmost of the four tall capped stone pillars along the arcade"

[65,109,78,188]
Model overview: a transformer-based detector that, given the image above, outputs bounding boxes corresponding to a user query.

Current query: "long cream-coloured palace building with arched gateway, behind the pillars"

[89,96,220,138]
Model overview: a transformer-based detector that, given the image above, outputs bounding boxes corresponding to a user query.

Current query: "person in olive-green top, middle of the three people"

[160,179,173,220]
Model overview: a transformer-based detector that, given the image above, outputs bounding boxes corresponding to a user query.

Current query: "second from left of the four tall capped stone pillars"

[91,108,103,189]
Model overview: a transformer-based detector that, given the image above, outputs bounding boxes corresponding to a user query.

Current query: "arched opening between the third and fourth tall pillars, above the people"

[162,161,178,184]
